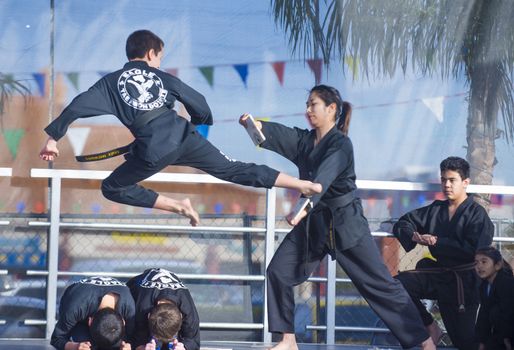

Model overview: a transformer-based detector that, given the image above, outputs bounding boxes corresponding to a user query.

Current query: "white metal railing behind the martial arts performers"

[0,168,514,344]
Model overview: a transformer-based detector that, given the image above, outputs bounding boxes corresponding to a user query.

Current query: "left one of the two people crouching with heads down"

[50,277,135,350]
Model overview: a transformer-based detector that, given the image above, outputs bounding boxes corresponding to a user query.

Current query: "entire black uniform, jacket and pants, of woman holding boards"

[262,122,428,348]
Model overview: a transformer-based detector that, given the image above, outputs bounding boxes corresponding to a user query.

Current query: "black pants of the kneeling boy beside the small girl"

[395,271,478,350]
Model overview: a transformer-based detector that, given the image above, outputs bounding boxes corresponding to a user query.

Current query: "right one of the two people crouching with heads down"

[127,268,200,350]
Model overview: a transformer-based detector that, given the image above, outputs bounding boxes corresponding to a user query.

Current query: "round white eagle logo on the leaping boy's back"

[118,68,168,111]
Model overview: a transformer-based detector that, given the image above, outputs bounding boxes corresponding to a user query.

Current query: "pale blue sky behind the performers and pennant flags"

[0,0,514,185]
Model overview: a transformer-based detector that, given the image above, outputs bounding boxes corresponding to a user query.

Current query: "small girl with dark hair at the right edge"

[475,247,514,350]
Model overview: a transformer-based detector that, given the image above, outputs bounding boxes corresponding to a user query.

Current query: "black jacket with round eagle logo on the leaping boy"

[45,61,212,164]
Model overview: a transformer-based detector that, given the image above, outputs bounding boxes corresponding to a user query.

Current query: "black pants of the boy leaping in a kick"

[102,132,278,208]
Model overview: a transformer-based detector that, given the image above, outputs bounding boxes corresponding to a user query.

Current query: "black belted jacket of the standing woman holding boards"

[262,122,370,253]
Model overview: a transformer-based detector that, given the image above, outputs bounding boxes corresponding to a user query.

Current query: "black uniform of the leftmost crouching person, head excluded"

[50,277,135,350]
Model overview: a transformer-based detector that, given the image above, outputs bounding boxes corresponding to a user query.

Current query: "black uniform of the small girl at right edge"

[475,271,514,350]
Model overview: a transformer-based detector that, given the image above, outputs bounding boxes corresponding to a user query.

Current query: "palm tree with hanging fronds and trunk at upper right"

[272,0,514,208]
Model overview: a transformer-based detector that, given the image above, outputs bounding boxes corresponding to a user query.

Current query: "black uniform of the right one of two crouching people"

[127,268,200,350]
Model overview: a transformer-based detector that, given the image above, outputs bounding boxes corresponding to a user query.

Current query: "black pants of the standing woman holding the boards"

[267,230,428,348]
